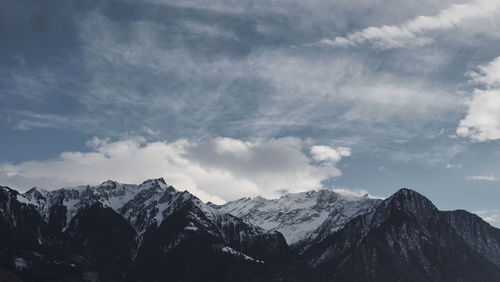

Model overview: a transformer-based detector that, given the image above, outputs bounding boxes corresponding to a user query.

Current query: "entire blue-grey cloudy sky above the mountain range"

[0,0,500,226]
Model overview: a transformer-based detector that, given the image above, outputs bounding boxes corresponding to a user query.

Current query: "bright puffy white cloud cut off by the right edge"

[456,57,500,142]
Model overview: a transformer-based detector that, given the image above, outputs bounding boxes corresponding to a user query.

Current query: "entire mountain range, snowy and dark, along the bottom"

[0,181,500,282]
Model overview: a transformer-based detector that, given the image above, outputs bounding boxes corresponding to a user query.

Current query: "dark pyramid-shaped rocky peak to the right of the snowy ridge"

[304,189,500,282]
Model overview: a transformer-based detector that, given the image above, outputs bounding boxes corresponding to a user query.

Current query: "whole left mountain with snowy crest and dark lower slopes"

[0,179,302,281]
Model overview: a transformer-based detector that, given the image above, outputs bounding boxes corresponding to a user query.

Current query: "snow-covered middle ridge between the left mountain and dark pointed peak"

[213,190,380,245]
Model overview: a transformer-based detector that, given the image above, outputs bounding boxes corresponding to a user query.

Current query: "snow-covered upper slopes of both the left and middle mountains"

[17,178,380,250]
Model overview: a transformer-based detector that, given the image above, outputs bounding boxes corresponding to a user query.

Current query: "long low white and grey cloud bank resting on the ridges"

[0,137,350,203]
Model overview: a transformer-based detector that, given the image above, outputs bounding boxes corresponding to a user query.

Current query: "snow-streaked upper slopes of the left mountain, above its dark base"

[17,178,265,241]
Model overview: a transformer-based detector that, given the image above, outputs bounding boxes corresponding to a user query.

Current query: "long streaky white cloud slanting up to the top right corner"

[319,0,500,49]
